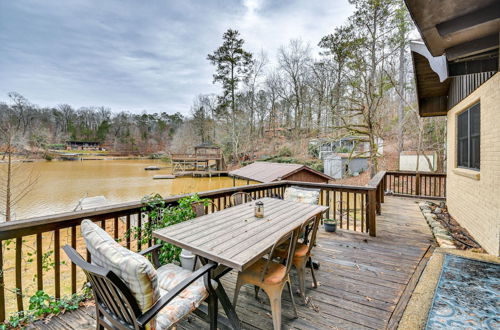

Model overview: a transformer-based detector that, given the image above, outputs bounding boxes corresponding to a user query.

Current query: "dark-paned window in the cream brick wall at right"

[457,103,480,171]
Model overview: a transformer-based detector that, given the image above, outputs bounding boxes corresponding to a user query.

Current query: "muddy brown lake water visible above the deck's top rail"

[0,160,246,219]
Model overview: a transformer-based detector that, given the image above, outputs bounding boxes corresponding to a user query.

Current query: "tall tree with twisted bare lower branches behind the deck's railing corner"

[330,0,393,177]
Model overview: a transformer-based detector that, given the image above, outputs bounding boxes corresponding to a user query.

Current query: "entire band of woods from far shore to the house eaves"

[0,0,445,174]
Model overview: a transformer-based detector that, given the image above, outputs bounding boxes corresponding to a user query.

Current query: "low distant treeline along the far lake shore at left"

[0,92,185,154]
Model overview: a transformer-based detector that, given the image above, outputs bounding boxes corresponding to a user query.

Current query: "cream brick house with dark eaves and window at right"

[405,0,500,255]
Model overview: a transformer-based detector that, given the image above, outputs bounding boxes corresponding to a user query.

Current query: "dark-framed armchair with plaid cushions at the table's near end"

[64,220,217,330]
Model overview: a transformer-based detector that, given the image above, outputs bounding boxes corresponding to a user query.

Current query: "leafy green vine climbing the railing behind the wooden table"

[132,194,209,265]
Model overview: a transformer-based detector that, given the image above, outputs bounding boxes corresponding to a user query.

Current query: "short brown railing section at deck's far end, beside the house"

[385,171,446,198]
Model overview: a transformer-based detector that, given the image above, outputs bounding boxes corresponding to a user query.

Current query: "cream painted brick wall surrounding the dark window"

[446,73,500,255]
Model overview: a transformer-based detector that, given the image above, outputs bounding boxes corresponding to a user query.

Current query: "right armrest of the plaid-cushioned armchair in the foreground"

[137,263,217,327]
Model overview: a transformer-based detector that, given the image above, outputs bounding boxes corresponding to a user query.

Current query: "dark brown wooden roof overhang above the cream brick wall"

[405,0,500,116]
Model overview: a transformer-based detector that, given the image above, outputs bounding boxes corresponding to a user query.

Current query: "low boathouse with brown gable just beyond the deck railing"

[229,162,332,183]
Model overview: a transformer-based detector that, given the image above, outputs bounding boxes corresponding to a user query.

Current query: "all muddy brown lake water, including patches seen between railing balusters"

[0,160,250,313]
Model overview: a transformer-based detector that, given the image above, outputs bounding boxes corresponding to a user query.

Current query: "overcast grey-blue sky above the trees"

[0,0,353,114]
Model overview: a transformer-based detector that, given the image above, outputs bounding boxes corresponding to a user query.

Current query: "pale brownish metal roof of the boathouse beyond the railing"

[229,162,332,183]
